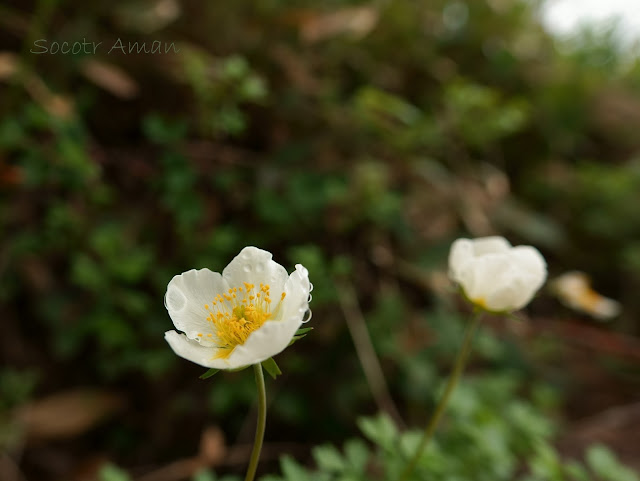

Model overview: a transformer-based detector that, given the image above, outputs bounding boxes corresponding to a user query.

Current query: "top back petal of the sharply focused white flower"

[222,247,289,297]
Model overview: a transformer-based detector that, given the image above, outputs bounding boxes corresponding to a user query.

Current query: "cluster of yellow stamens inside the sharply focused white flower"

[198,282,286,359]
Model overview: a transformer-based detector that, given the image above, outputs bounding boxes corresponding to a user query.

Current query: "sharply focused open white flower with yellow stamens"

[165,247,310,369]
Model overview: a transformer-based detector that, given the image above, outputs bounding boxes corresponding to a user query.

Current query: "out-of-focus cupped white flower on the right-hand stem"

[449,236,547,312]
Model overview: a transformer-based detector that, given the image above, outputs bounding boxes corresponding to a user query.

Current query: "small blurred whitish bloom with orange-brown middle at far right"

[550,271,621,321]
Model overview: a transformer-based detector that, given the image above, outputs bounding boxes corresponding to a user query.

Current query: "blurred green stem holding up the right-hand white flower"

[398,311,482,481]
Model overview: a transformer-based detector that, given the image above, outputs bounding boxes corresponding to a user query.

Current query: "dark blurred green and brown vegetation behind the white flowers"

[0,0,640,481]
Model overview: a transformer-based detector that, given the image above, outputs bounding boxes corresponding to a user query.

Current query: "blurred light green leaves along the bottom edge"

[261,402,639,481]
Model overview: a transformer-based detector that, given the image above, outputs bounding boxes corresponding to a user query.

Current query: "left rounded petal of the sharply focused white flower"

[164,268,229,345]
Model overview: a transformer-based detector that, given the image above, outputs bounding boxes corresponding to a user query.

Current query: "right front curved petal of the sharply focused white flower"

[225,264,310,369]
